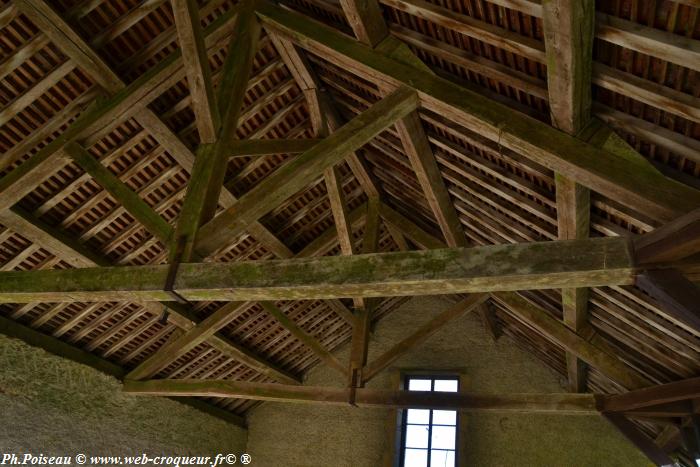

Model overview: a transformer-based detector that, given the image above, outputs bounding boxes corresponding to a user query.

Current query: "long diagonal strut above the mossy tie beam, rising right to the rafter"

[194,88,418,257]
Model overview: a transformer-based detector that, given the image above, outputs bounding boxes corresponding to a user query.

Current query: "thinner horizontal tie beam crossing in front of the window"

[124,379,598,415]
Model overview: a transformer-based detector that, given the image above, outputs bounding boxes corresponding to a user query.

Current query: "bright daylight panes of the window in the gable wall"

[401,376,459,467]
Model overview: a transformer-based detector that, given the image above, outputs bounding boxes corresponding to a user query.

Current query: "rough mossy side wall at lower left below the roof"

[0,336,246,457]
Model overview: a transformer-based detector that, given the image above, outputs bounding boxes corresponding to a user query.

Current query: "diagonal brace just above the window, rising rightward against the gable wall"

[362,294,489,382]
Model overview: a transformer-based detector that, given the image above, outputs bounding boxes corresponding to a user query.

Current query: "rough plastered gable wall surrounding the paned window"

[247,297,651,467]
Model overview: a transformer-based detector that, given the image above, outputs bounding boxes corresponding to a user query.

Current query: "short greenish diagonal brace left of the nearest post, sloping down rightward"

[63,142,173,245]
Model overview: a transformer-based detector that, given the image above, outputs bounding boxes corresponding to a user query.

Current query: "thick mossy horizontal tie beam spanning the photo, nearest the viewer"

[0,237,637,303]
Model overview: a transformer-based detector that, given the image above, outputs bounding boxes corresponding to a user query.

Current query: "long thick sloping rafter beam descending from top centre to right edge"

[257,2,700,221]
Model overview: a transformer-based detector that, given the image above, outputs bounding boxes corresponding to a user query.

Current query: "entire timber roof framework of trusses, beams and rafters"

[0,0,700,465]
